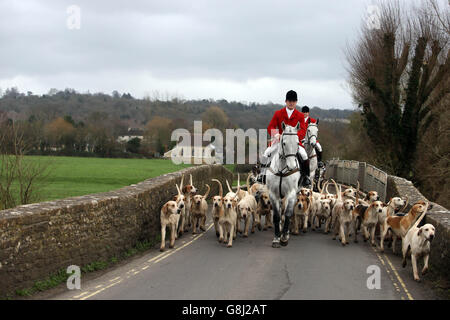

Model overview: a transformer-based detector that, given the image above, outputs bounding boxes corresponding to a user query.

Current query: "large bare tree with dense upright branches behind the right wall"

[346,1,450,177]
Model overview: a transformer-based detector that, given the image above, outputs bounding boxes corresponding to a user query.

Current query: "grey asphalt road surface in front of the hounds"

[45,208,435,300]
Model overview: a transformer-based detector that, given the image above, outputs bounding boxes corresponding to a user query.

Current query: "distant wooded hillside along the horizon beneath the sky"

[0,88,353,135]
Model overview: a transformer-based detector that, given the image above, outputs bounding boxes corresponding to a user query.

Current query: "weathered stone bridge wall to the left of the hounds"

[0,165,233,297]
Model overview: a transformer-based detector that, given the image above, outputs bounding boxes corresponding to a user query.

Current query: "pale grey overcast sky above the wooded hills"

[0,0,394,108]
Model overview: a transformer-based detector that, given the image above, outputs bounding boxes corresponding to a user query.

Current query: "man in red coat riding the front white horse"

[260,90,311,187]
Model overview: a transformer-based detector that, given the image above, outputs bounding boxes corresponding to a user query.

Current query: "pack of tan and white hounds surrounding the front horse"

[160,169,435,281]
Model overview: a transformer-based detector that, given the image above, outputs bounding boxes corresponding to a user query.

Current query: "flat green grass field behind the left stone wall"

[8,156,191,202]
